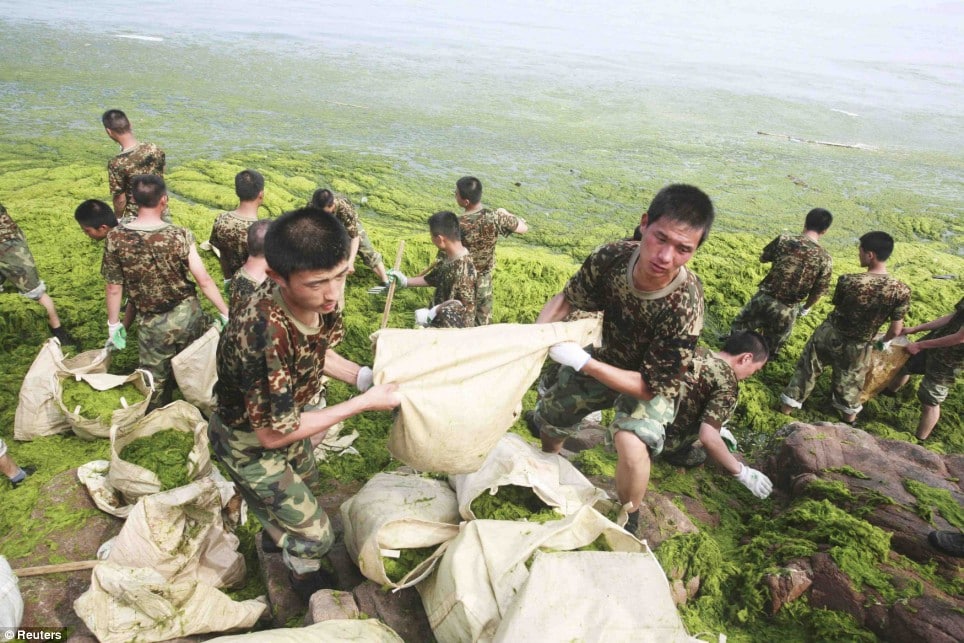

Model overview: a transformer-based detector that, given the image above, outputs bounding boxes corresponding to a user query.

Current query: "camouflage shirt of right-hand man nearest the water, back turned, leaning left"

[760,234,833,306]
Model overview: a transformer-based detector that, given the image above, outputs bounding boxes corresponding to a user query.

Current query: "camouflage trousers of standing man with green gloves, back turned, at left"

[137,297,211,406]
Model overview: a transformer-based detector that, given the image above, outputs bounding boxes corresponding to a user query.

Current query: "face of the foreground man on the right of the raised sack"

[633,215,703,290]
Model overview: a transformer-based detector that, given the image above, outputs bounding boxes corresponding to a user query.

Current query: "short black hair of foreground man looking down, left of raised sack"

[264,207,351,279]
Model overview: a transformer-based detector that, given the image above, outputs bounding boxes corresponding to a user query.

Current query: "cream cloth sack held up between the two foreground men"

[372,319,599,474]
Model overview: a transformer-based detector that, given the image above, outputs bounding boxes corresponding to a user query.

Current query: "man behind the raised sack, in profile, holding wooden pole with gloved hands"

[372,212,476,328]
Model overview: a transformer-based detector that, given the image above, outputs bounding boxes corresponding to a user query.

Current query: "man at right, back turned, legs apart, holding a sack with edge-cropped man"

[780,232,910,423]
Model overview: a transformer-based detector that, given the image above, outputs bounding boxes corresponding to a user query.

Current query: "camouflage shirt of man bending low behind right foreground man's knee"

[666,347,740,453]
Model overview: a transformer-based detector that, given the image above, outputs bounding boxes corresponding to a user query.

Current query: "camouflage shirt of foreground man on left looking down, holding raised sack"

[214,279,343,457]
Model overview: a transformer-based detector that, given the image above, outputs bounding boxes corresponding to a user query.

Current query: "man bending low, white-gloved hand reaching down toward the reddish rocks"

[663,331,773,498]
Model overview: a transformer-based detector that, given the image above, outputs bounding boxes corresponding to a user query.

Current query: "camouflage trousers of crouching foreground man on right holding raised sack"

[535,366,676,456]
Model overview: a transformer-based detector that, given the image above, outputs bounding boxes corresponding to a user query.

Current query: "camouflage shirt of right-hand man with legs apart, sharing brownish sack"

[828,272,910,342]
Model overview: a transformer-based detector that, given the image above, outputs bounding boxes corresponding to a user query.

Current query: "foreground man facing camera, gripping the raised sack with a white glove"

[531,184,714,529]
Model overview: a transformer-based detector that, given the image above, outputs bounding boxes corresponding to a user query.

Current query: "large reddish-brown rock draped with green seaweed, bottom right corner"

[766,423,964,643]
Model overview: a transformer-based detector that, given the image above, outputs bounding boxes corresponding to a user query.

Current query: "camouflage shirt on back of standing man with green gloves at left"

[100,223,196,314]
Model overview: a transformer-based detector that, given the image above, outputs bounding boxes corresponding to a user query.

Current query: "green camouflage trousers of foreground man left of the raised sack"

[208,413,335,576]
